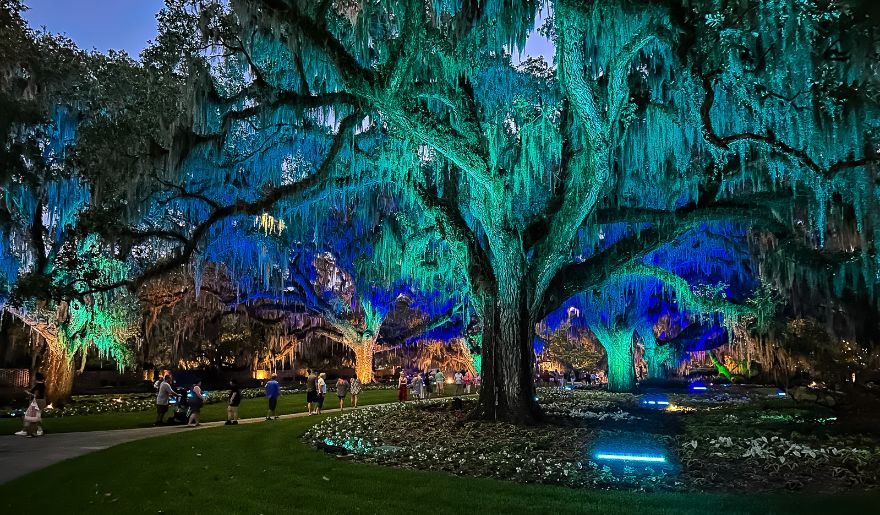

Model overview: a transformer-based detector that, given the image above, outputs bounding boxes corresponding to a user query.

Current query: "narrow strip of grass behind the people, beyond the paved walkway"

[0,390,397,434]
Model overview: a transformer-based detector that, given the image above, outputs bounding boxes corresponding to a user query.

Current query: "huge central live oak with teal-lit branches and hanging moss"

[15,0,880,423]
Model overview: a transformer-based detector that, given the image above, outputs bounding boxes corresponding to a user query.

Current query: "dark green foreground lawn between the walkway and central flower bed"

[0,415,880,515]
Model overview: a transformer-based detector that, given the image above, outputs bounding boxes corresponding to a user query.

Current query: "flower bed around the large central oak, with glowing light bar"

[305,389,880,493]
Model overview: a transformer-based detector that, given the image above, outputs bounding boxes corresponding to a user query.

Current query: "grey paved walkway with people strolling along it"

[0,404,350,484]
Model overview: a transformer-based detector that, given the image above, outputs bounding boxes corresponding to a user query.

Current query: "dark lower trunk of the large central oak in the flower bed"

[475,290,540,424]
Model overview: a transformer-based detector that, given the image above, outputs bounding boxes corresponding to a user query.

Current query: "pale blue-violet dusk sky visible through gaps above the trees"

[25,0,553,63]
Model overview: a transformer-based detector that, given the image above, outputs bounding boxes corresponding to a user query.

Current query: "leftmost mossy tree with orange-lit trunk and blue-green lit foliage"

[0,1,137,401]
